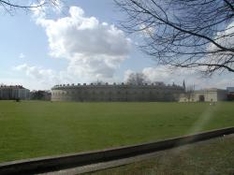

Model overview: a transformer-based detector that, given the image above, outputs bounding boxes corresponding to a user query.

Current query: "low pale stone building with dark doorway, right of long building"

[179,88,227,102]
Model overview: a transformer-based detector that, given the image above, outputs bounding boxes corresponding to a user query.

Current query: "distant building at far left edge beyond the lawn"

[0,85,30,100]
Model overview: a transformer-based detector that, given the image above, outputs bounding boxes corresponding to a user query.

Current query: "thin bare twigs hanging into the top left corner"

[0,0,58,14]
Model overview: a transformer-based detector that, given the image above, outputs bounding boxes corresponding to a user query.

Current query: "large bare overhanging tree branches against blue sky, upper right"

[115,0,234,75]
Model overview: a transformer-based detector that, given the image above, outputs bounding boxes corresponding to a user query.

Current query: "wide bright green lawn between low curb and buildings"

[0,101,234,162]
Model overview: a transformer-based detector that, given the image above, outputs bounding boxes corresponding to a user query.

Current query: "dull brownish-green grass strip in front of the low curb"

[86,134,234,175]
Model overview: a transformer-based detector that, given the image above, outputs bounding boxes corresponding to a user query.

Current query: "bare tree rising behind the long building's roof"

[126,73,147,85]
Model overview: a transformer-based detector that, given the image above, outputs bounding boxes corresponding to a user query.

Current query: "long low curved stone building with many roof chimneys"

[51,83,184,102]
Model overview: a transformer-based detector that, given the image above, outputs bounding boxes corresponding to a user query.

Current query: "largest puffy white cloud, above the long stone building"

[34,6,131,82]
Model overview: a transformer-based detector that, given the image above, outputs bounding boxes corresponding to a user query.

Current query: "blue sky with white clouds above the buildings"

[0,0,234,90]
